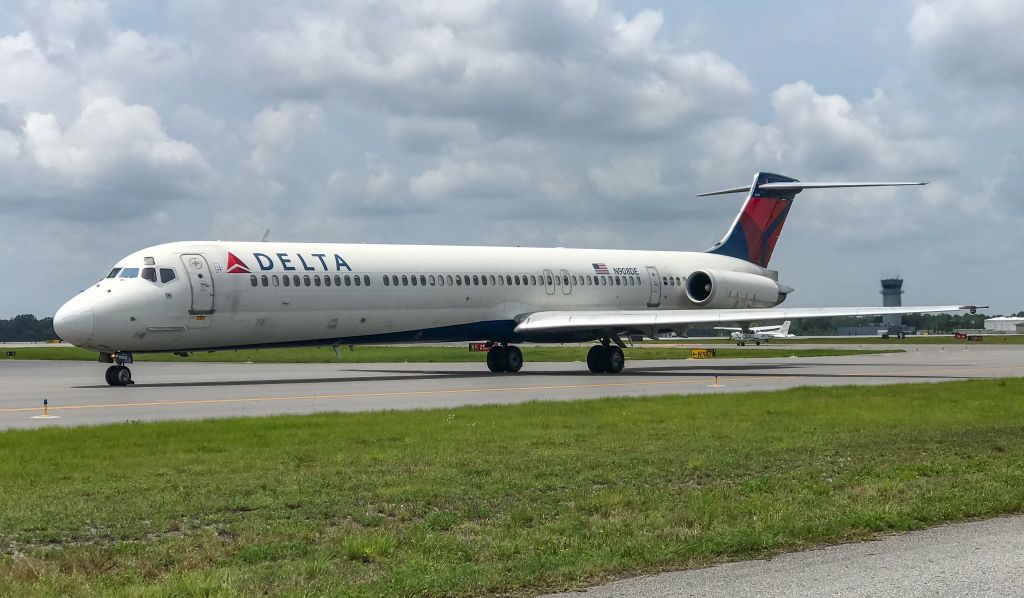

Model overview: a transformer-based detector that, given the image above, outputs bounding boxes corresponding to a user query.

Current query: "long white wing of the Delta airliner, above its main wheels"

[515,305,977,334]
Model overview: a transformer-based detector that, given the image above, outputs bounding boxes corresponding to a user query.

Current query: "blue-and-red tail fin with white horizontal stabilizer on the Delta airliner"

[698,172,927,267]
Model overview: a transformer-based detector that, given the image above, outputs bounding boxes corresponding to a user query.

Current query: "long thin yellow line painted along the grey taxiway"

[0,365,1024,413]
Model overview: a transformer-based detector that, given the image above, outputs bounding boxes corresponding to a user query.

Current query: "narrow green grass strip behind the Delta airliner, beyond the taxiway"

[0,345,894,364]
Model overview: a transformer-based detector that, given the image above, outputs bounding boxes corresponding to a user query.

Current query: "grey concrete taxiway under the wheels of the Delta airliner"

[0,345,1024,429]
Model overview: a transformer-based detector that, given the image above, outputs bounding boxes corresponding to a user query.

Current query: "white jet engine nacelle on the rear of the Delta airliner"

[686,270,785,309]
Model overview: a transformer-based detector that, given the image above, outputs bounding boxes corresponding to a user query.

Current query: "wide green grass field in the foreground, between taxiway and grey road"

[0,379,1024,596]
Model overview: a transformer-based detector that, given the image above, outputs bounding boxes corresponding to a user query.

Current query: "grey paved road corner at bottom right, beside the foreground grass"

[552,516,1024,598]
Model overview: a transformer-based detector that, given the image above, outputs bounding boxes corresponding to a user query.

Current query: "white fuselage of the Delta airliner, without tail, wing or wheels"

[51,242,778,352]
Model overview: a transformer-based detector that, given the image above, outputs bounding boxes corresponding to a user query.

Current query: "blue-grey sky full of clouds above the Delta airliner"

[0,0,1024,316]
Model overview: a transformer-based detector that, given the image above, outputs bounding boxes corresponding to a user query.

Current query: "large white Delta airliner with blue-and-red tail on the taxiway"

[53,172,973,386]
